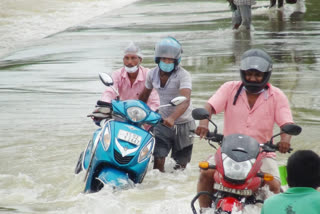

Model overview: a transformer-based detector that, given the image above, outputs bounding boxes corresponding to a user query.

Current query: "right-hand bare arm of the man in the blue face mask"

[163,88,191,127]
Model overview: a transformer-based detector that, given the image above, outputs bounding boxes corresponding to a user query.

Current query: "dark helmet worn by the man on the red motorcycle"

[240,49,272,93]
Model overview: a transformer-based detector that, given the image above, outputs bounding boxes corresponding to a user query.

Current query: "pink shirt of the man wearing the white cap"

[101,66,160,110]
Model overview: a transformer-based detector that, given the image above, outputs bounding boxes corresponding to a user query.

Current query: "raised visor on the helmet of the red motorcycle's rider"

[240,56,271,72]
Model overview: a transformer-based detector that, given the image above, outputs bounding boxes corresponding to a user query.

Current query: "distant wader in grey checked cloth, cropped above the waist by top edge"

[227,0,256,30]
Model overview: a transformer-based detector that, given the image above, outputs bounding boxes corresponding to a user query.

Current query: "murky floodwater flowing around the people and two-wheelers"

[0,0,320,214]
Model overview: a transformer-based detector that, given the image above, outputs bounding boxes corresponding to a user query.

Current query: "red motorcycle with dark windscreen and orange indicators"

[191,108,302,214]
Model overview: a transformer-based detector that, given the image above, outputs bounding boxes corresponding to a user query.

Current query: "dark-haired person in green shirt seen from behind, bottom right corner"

[261,150,320,214]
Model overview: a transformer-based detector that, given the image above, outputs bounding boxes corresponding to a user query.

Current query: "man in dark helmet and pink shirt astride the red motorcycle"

[196,49,293,208]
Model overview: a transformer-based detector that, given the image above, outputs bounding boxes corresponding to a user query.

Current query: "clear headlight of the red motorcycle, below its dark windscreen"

[222,154,252,180]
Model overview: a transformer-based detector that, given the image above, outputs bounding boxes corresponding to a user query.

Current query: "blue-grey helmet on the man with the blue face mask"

[154,36,182,67]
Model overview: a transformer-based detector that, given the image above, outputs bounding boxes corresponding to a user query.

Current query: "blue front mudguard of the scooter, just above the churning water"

[97,167,132,188]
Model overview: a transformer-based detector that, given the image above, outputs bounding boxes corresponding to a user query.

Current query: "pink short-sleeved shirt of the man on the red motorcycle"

[208,81,293,143]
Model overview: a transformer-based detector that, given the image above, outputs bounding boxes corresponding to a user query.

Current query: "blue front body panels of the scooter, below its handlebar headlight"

[83,117,155,192]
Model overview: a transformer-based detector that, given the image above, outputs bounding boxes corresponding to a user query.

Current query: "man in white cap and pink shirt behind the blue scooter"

[101,42,160,110]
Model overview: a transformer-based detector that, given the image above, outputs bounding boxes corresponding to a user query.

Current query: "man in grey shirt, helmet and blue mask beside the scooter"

[140,37,195,172]
